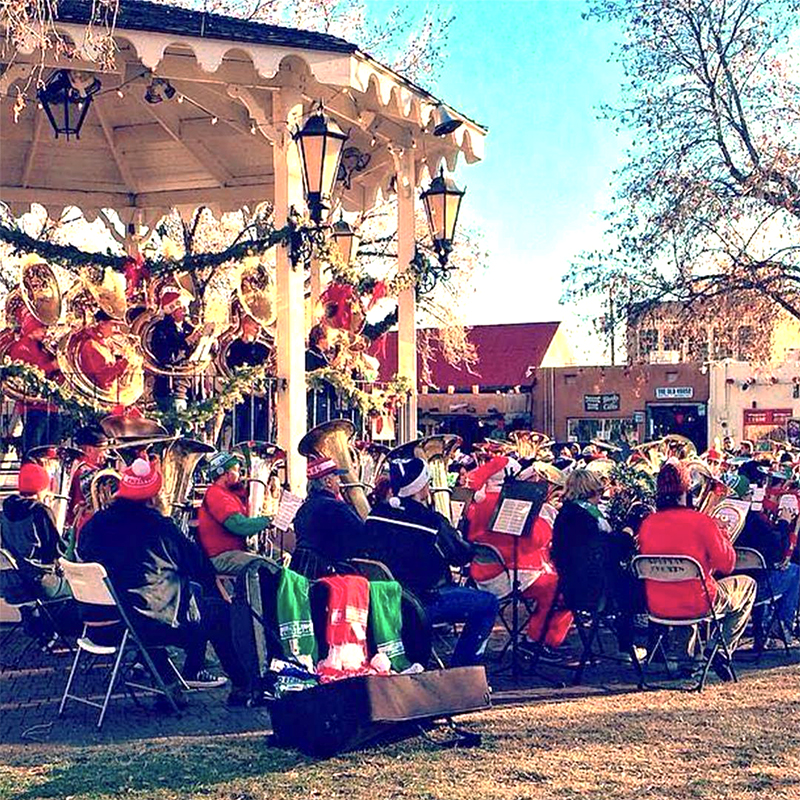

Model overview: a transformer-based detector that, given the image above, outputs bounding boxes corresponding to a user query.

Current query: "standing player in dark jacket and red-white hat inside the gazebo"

[150,286,195,411]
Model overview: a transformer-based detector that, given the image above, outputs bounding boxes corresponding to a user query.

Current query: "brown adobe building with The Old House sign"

[532,363,709,451]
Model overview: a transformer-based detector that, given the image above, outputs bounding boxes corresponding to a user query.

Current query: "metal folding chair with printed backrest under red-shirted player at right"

[633,555,738,692]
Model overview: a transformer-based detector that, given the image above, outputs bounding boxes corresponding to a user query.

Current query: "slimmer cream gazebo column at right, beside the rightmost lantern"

[395,150,417,441]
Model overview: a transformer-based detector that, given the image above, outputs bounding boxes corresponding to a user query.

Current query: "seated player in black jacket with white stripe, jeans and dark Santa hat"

[365,458,498,667]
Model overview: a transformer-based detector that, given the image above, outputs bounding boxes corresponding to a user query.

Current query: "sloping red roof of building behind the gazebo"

[371,322,561,389]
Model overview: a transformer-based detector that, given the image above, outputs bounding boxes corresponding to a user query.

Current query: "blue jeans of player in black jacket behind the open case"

[425,586,498,667]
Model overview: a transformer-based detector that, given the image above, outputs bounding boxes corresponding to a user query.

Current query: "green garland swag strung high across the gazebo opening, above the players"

[0,223,292,276]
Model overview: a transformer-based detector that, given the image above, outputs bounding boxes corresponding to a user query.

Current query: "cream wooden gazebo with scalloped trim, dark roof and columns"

[0,0,486,489]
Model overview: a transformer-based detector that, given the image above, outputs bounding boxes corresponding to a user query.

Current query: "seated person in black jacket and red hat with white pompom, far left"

[77,459,247,698]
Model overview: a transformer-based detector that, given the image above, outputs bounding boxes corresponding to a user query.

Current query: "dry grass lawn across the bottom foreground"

[0,664,800,800]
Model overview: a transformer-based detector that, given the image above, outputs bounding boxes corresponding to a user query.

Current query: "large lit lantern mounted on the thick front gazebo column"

[294,102,348,224]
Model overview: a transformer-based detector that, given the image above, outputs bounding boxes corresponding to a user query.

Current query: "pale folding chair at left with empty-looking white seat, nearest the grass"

[58,558,181,728]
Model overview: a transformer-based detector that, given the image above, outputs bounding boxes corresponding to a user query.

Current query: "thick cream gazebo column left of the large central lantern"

[272,88,306,494]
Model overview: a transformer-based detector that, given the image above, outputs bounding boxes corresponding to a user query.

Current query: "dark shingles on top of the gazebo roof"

[56,0,358,53]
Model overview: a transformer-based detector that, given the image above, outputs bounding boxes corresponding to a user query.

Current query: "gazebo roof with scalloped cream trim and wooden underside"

[0,0,486,222]
